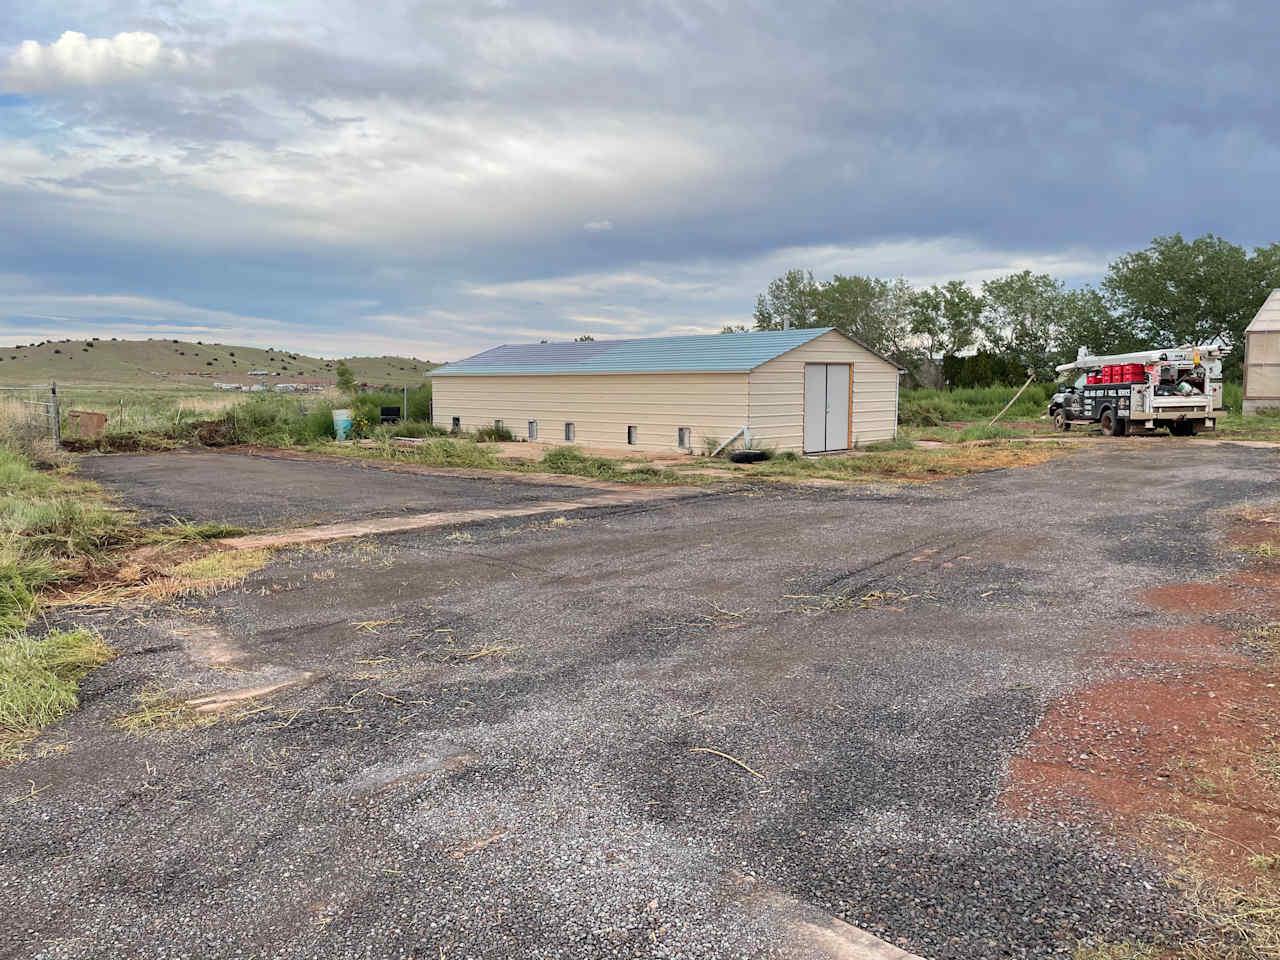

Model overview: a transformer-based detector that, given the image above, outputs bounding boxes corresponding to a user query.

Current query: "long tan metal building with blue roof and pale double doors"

[430,328,899,453]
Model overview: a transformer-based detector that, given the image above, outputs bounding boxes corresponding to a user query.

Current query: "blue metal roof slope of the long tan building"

[429,326,835,376]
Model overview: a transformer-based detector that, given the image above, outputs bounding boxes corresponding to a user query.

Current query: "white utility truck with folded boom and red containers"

[1048,346,1230,436]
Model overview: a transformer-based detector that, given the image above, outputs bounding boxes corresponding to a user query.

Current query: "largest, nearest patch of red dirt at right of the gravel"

[1002,668,1280,878]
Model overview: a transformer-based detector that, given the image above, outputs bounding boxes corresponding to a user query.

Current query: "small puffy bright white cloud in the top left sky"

[3,29,192,92]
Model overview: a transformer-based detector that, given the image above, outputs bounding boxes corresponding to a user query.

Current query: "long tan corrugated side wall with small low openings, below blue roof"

[431,374,748,453]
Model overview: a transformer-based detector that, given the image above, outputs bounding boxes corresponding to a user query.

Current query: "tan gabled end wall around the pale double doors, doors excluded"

[748,333,897,451]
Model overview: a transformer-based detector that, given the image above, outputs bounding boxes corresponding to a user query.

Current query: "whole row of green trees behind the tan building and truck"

[724,233,1280,387]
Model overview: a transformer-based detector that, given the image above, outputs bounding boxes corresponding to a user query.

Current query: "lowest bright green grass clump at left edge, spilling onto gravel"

[0,628,115,758]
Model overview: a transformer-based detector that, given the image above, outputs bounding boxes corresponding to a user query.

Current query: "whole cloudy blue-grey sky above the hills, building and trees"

[0,0,1280,360]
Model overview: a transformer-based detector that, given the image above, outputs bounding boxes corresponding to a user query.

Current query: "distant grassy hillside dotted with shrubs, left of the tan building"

[0,338,439,388]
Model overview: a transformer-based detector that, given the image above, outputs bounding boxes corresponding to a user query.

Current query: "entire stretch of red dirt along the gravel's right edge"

[1001,542,1280,887]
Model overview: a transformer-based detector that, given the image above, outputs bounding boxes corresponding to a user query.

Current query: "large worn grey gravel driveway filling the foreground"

[0,445,1280,960]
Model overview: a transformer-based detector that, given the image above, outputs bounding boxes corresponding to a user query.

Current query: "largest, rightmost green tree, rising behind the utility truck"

[1102,233,1280,376]
